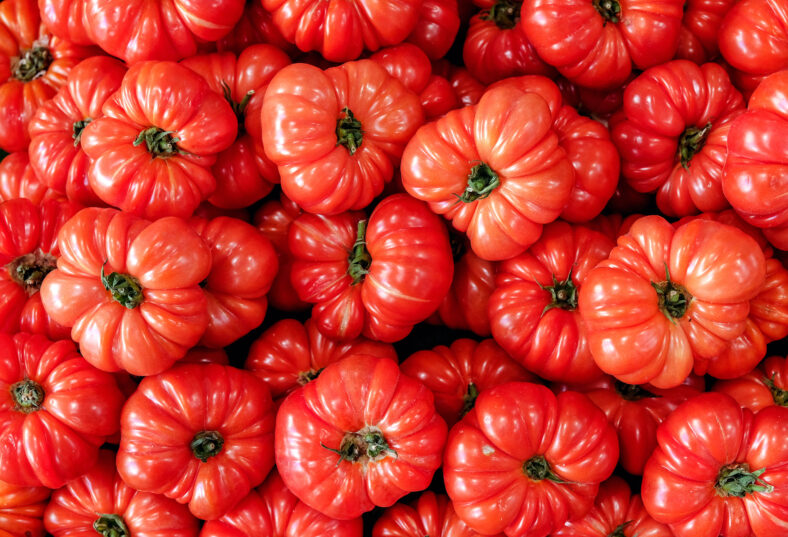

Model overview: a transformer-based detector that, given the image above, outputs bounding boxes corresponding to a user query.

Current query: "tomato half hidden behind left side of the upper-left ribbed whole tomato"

[29,56,126,205]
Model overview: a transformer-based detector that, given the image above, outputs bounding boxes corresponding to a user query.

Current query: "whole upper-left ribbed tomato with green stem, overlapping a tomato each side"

[82,62,238,218]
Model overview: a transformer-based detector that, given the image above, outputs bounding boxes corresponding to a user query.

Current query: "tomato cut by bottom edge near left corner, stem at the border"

[44,450,199,537]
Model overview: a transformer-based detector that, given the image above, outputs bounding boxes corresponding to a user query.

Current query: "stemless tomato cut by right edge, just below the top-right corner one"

[722,69,788,249]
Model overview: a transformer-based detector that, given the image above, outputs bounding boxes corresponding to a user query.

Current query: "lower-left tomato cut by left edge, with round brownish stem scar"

[0,333,124,488]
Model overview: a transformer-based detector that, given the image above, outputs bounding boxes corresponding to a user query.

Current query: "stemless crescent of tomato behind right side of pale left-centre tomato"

[189,216,279,348]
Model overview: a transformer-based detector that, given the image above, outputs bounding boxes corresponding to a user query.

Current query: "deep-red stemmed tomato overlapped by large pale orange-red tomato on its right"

[489,222,614,383]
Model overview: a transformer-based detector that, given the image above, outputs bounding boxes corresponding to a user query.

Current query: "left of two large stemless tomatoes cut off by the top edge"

[84,0,244,62]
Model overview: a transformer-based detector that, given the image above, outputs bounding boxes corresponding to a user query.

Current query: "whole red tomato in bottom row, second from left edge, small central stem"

[117,364,275,520]
